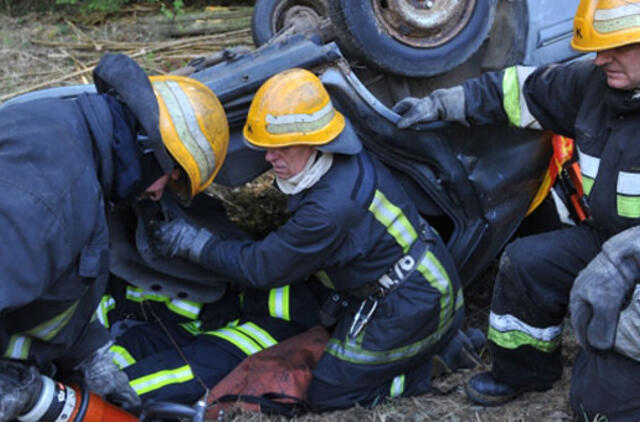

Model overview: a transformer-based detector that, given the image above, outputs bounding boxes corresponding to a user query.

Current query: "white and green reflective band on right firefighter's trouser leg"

[487,311,562,352]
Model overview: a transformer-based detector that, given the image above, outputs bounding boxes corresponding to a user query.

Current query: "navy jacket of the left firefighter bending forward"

[0,95,113,364]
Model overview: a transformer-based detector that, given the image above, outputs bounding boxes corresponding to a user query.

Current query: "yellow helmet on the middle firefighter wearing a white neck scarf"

[243,68,345,148]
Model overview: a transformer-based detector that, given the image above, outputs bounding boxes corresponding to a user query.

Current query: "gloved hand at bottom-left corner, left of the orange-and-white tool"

[0,359,42,422]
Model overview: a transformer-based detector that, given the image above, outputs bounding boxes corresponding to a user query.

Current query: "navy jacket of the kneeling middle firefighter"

[200,151,420,290]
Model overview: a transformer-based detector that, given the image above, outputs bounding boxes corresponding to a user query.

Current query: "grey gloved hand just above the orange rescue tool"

[76,342,141,410]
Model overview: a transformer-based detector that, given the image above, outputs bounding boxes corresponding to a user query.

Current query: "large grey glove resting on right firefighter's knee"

[569,227,640,350]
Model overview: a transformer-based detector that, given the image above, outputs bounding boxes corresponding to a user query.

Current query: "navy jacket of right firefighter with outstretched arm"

[464,60,640,236]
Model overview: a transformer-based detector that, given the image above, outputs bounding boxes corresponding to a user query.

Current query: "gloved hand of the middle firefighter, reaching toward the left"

[151,218,212,262]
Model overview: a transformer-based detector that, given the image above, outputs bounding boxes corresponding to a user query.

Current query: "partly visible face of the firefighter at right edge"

[595,43,640,90]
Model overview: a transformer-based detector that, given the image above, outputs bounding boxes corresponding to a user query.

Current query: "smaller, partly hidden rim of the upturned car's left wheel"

[271,0,328,34]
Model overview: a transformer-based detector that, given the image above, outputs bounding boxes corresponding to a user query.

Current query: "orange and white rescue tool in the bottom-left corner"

[18,375,138,422]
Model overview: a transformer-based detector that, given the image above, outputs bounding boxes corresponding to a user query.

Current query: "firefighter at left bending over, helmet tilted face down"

[0,55,228,421]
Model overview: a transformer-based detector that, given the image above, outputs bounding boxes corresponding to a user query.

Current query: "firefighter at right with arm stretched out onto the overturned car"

[394,0,640,421]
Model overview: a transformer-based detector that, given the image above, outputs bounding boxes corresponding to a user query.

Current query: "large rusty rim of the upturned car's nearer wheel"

[371,0,476,48]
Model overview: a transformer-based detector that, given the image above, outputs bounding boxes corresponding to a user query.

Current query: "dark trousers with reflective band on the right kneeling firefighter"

[487,225,640,421]
